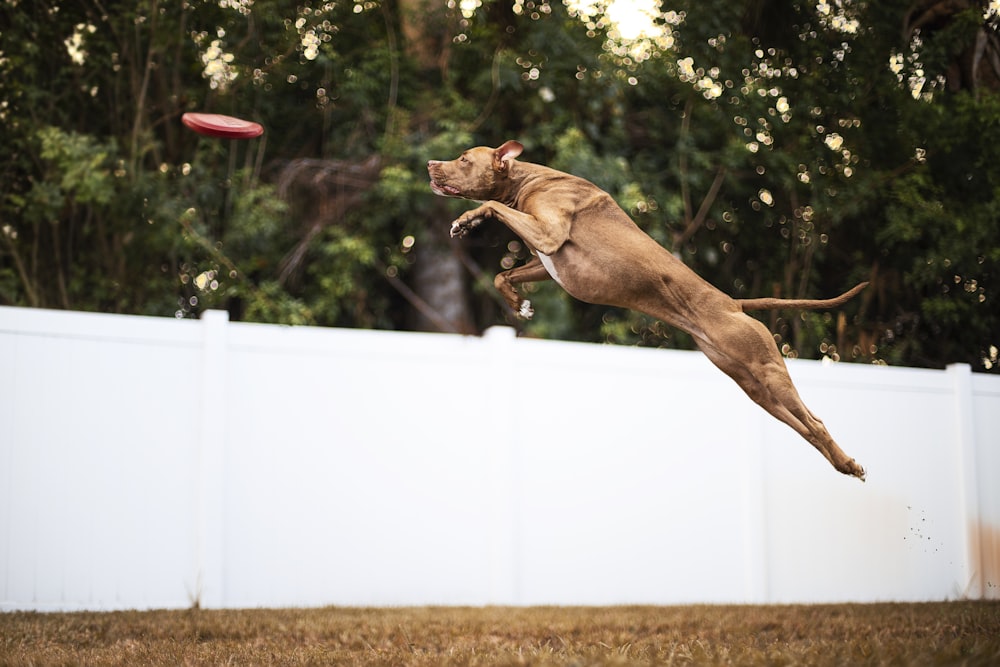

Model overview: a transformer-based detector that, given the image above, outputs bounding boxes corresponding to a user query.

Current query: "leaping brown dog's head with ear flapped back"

[427,141,524,201]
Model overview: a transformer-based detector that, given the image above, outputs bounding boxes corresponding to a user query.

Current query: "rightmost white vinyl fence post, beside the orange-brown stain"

[947,364,985,600]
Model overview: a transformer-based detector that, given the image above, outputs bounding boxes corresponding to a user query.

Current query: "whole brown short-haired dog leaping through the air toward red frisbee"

[427,141,867,480]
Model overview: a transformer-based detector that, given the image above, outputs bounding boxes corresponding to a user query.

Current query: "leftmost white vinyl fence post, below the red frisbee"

[195,310,229,608]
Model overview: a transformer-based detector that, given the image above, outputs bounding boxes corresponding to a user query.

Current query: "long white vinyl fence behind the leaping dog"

[0,308,1000,610]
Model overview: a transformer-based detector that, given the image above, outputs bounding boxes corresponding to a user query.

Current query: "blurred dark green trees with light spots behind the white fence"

[0,0,1000,372]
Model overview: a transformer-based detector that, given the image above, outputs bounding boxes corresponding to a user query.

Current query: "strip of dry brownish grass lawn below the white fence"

[0,602,1000,666]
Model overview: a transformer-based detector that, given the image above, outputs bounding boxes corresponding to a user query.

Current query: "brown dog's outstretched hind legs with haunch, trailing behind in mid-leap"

[695,313,865,480]
